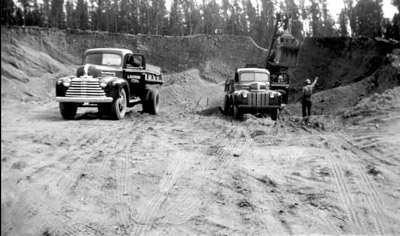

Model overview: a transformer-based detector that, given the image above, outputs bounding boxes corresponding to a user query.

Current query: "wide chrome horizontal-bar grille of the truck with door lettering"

[65,78,106,97]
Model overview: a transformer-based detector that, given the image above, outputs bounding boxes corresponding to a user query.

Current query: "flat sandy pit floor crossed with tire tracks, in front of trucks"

[1,98,400,235]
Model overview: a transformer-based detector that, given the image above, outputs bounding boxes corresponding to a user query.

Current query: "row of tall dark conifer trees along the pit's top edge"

[1,0,400,46]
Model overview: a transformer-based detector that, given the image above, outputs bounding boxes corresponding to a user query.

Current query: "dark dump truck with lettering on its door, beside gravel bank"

[56,48,163,120]
